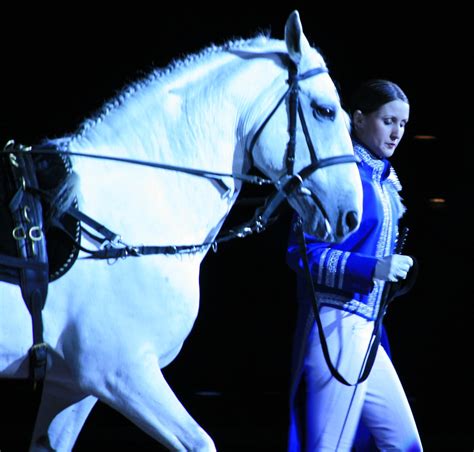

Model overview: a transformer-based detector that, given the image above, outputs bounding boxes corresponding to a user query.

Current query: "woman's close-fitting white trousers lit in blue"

[303,307,422,452]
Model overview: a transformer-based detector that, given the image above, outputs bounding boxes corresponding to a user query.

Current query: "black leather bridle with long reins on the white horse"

[4,61,358,259]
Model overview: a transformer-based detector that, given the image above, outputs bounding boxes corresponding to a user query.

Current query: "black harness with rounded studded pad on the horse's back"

[0,142,80,382]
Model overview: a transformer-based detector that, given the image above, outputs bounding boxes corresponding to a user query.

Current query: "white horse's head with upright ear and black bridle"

[251,11,362,242]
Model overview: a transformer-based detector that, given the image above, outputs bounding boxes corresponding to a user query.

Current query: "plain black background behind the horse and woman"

[0,3,468,452]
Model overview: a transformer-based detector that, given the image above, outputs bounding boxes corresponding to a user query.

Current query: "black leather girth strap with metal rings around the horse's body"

[0,144,49,381]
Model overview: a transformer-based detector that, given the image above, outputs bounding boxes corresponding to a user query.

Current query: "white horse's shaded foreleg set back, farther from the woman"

[30,379,97,452]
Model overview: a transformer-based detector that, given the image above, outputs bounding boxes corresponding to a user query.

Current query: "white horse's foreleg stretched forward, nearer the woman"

[91,355,216,452]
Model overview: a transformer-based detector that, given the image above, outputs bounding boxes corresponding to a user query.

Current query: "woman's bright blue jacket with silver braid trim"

[287,142,405,320]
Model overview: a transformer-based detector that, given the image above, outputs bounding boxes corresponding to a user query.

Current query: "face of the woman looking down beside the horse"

[353,100,410,158]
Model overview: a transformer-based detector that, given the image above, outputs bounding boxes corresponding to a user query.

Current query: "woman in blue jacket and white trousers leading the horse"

[287,80,422,452]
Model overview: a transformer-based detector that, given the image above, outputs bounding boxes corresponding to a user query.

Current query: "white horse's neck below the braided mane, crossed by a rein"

[70,56,286,251]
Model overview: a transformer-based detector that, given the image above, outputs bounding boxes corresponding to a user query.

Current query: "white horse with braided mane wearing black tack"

[0,11,362,451]
